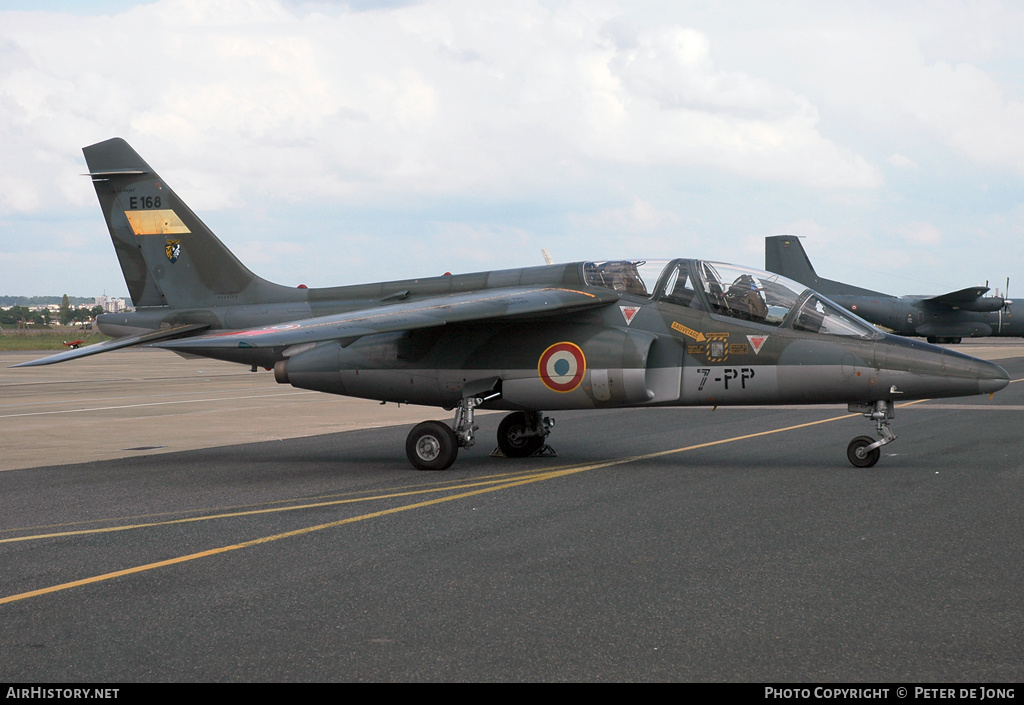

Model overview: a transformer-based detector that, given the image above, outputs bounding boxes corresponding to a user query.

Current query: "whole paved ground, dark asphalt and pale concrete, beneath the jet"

[0,340,1024,682]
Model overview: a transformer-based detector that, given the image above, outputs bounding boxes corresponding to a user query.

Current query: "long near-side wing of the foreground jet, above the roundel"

[157,287,618,355]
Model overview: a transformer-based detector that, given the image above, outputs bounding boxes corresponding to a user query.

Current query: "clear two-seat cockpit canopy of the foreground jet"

[584,259,882,340]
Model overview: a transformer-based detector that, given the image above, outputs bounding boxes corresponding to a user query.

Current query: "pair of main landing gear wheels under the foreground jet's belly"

[406,395,555,470]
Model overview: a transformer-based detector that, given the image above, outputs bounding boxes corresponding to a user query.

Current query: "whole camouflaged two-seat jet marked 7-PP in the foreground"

[15,138,1009,470]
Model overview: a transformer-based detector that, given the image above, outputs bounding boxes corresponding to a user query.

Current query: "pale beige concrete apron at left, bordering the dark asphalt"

[0,348,449,470]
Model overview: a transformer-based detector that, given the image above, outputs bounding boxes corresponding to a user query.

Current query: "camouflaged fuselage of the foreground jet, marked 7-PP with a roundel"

[99,260,1001,410]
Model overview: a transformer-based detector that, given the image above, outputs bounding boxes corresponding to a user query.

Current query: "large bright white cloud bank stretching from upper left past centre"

[0,0,881,219]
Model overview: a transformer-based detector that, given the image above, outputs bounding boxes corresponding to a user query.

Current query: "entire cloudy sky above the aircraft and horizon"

[0,0,1024,296]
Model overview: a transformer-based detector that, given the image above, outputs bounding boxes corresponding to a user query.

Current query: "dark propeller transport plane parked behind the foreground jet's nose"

[765,235,1024,343]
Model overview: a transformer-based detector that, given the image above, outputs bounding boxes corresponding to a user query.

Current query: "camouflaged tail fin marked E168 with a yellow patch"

[82,137,294,308]
